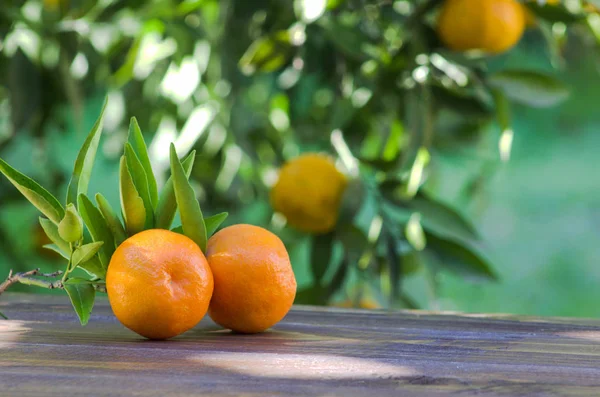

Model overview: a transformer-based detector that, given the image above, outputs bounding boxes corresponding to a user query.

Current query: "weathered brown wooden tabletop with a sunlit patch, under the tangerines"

[0,295,600,397]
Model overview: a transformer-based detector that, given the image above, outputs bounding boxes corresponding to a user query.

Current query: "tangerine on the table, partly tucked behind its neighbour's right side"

[206,225,296,333]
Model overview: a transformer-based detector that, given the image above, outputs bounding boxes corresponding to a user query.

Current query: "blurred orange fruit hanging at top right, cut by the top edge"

[437,0,525,54]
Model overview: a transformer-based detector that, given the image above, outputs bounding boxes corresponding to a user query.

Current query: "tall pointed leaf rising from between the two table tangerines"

[171,144,206,252]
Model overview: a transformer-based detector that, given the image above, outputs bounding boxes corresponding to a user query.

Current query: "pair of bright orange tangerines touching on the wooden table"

[106,225,296,339]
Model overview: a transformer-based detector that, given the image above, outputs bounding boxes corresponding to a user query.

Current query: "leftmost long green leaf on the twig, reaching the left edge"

[0,159,65,225]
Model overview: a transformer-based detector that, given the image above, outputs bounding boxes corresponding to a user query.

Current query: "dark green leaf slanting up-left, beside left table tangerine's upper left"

[78,194,116,269]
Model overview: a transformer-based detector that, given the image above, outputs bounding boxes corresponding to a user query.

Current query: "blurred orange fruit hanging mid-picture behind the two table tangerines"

[271,153,347,234]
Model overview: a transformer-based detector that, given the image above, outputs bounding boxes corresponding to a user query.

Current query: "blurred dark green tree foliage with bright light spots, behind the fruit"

[0,0,600,307]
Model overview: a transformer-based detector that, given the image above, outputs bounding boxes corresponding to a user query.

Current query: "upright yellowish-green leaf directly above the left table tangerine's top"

[119,156,146,236]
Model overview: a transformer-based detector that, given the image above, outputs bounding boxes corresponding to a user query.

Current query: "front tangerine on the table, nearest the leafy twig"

[106,229,213,339]
